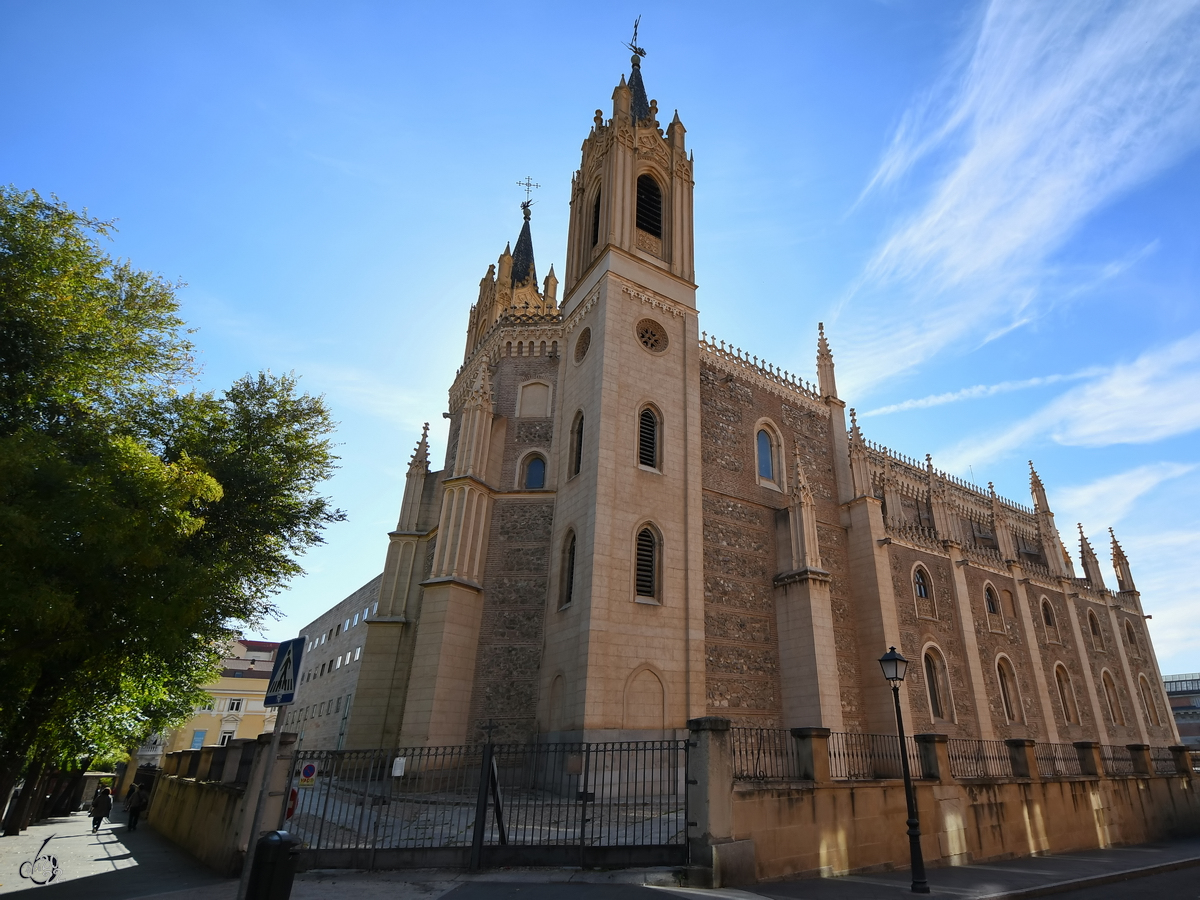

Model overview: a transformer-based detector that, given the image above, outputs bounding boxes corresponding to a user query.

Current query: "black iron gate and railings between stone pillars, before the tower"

[287,740,688,869]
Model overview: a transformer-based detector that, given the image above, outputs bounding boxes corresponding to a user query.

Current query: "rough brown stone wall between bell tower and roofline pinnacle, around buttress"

[700,364,860,730]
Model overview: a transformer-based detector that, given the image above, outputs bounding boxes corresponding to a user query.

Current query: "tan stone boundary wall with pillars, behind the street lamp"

[688,716,1200,887]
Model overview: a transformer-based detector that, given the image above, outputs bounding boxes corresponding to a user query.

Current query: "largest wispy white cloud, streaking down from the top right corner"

[835,0,1200,386]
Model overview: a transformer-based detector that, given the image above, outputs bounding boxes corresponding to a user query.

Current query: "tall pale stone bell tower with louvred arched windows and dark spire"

[539,46,704,738]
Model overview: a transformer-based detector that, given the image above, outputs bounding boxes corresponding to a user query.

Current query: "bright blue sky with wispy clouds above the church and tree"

[0,0,1200,673]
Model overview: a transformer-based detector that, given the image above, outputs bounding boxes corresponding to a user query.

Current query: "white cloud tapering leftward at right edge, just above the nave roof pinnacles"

[938,332,1200,472]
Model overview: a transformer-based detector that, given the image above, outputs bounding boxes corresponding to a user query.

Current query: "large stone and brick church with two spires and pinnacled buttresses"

[344,47,1180,749]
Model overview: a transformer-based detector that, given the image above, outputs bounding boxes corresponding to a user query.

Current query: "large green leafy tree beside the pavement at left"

[0,188,343,833]
